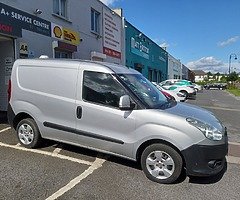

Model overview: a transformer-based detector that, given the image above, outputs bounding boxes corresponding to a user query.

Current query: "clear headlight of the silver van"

[186,118,223,140]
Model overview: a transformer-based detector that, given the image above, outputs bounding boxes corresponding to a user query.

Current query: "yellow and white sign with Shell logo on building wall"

[52,23,80,45]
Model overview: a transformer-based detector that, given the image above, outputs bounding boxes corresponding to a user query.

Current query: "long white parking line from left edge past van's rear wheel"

[0,142,93,165]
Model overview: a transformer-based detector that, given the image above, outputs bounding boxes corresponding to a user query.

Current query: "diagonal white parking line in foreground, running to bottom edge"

[46,158,106,200]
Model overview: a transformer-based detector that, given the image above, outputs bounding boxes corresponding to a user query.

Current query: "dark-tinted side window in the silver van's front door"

[82,71,126,108]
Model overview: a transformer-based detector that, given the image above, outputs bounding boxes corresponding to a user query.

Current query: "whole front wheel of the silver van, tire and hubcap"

[141,143,183,184]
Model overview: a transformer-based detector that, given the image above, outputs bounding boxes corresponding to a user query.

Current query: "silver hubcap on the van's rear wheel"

[18,124,34,145]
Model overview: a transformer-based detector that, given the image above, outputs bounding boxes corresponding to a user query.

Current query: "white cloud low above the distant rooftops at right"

[186,56,228,73]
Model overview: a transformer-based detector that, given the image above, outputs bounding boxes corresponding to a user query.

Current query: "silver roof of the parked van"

[15,58,139,74]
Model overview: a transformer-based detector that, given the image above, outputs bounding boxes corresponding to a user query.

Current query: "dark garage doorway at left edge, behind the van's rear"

[0,35,15,111]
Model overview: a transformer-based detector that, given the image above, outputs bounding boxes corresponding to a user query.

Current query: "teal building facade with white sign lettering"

[124,20,168,82]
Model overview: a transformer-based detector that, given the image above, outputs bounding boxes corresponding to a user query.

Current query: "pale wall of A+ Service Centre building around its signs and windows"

[1,0,125,64]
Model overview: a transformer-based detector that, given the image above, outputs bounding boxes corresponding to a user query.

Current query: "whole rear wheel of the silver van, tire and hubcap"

[16,118,43,148]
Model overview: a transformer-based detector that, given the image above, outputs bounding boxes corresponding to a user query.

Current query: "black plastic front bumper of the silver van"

[182,137,228,176]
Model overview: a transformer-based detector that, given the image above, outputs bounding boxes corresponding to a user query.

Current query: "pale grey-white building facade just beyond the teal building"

[168,54,182,79]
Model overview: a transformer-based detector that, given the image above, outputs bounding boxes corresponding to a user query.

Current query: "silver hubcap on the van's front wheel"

[146,151,175,179]
